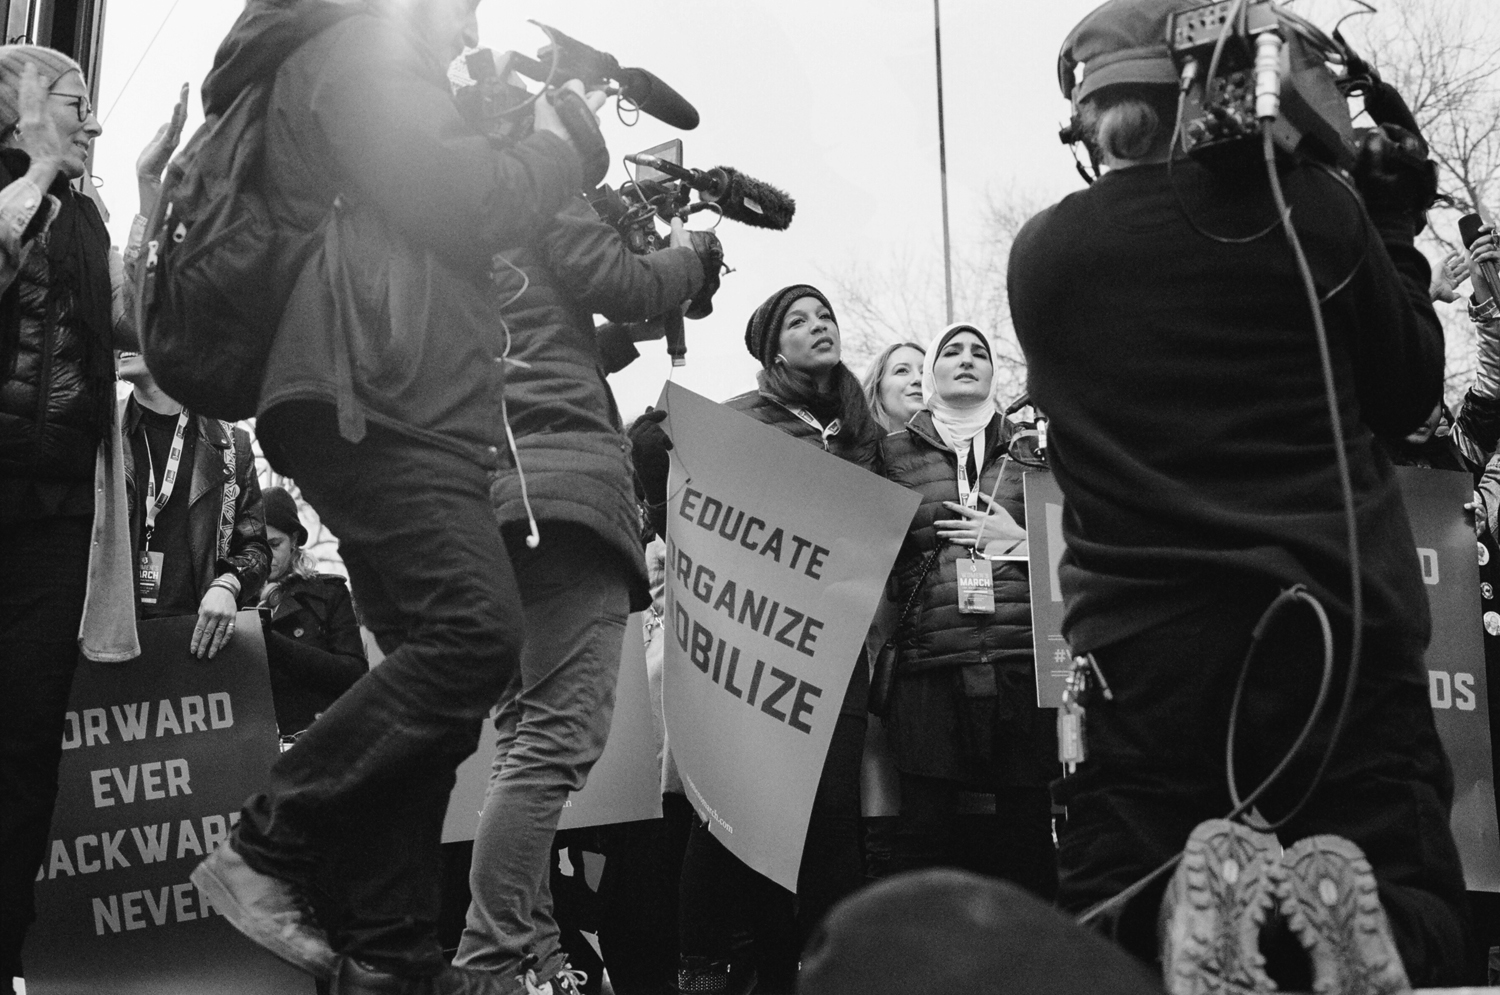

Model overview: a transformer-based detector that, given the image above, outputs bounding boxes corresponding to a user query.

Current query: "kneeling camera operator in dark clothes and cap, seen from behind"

[1010,0,1466,990]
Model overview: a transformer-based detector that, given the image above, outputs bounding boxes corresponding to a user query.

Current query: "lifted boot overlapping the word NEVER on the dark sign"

[191,843,339,978]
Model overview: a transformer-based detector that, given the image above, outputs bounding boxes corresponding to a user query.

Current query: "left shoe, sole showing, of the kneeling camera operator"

[1161,819,1281,995]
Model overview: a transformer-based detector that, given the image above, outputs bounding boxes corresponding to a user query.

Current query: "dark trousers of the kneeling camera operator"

[1053,584,1467,987]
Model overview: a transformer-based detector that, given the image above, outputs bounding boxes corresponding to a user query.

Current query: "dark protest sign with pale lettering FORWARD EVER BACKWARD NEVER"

[24,611,312,995]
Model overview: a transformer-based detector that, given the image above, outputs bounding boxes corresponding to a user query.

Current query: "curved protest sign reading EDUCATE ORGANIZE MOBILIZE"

[662,384,918,890]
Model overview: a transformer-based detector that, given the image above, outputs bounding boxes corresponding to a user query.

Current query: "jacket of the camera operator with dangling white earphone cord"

[491,197,704,611]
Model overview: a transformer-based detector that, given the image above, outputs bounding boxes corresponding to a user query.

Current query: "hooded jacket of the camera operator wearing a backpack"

[219,0,581,467]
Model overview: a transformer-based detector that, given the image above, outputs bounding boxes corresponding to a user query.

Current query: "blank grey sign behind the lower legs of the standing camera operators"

[443,612,662,843]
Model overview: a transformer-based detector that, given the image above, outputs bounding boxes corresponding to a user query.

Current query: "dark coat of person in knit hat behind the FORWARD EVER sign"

[261,575,369,735]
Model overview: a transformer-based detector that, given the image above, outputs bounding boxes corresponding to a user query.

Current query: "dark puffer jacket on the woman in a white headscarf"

[881,411,1035,680]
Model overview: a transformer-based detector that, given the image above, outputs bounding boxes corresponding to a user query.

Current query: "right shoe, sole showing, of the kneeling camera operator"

[1278,836,1412,995]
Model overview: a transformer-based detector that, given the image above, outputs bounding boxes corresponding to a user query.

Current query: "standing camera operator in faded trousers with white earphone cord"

[455,93,719,992]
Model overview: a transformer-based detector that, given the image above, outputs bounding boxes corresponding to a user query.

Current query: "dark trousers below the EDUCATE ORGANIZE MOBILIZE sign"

[680,714,866,992]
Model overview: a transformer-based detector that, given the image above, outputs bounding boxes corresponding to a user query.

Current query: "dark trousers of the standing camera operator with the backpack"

[233,404,524,974]
